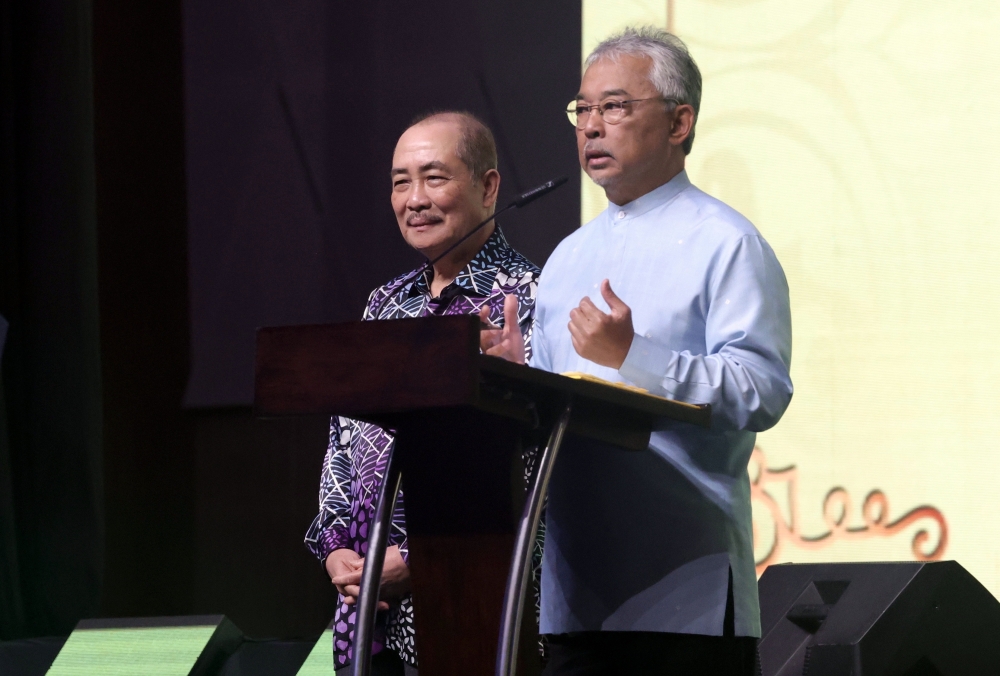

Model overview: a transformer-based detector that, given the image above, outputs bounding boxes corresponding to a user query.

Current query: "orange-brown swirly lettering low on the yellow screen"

[750,448,948,575]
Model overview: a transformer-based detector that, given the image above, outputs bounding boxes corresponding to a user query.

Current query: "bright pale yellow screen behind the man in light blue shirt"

[584,0,1000,595]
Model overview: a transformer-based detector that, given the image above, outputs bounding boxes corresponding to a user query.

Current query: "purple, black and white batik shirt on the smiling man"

[305,227,540,669]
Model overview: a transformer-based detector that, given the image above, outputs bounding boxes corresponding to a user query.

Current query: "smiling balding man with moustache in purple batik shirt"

[306,113,539,675]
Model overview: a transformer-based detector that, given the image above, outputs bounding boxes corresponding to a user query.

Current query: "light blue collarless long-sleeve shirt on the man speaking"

[531,172,792,636]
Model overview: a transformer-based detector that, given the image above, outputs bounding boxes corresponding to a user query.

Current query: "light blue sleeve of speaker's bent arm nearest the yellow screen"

[620,235,792,432]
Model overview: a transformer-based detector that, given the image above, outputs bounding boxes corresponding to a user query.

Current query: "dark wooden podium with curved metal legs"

[254,316,710,676]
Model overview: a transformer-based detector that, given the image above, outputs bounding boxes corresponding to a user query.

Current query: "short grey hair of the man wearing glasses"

[584,26,701,155]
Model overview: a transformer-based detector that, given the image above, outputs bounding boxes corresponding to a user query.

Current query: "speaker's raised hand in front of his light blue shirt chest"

[569,279,635,369]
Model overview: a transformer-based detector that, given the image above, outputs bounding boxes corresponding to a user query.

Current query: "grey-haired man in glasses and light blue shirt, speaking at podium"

[486,28,792,675]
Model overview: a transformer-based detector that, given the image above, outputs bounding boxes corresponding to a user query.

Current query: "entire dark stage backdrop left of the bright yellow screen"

[0,0,580,638]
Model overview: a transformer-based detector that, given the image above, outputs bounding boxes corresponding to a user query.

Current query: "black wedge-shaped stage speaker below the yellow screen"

[758,561,1000,676]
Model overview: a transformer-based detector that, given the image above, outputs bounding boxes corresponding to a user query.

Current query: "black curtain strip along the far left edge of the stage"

[0,0,104,639]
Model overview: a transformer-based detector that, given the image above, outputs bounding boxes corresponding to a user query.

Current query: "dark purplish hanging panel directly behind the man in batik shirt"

[184,0,580,406]
